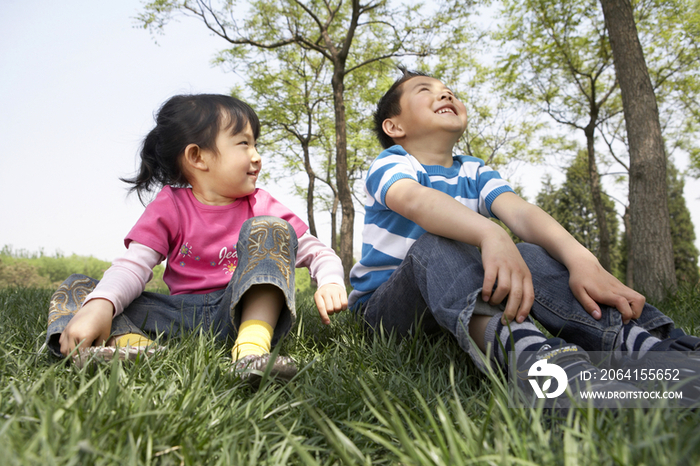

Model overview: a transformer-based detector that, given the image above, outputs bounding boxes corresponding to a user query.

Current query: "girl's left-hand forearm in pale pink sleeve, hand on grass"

[59,241,163,356]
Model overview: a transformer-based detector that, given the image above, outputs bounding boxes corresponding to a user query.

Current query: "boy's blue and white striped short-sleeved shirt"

[349,145,513,308]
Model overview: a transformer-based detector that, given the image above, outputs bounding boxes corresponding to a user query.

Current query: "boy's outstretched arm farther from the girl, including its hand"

[491,193,645,323]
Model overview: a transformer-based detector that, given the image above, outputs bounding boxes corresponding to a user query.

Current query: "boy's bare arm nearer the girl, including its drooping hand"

[385,178,535,322]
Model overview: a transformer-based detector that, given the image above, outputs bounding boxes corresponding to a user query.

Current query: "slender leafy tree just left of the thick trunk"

[496,0,619,270]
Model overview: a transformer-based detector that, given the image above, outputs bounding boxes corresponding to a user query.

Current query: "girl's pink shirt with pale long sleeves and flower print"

[85,186,343,315]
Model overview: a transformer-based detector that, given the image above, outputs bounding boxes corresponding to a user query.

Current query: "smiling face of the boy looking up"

[385,76,467,144]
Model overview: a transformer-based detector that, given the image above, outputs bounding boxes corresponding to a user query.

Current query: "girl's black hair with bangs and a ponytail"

[120,94,260,204]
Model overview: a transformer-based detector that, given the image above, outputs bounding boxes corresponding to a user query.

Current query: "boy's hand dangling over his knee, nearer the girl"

[480,227,535,325]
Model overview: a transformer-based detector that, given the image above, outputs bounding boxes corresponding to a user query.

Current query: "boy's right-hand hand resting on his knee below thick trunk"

[569,260,646,323]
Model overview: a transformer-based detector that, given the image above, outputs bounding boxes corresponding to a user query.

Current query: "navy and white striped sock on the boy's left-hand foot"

[484,314,547,367]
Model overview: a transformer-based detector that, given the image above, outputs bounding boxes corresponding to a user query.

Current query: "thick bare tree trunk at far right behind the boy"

[601,0,676,301]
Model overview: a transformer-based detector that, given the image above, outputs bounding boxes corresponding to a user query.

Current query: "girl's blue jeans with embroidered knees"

[46,217,298,357]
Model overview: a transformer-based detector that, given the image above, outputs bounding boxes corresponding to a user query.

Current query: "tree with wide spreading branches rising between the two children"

[139,0,468,280]
